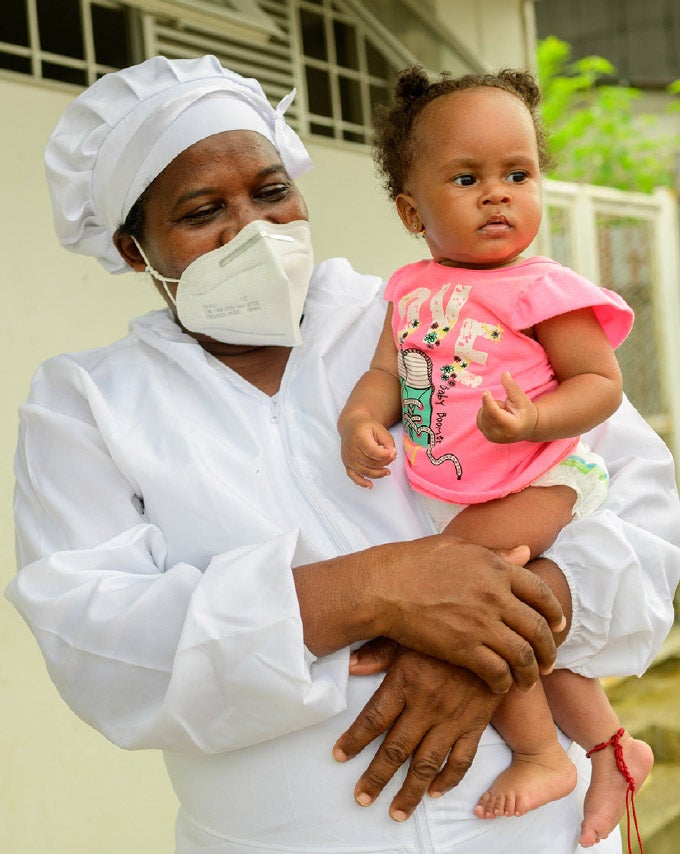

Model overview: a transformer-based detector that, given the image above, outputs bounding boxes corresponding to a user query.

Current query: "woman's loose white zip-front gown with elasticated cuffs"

[6,259,680,854]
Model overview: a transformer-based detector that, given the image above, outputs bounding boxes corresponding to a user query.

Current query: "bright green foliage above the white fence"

[537,36,680,192]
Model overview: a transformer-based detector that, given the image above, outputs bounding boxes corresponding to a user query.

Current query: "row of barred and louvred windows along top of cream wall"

[0,0,470,144]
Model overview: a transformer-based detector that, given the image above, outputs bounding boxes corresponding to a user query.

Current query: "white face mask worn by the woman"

[135,220,314,347]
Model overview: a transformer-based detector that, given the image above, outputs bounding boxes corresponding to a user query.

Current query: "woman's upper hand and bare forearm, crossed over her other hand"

[294,532,565,693]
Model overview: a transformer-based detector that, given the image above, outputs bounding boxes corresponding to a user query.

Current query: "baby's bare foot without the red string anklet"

[474,742,577,818]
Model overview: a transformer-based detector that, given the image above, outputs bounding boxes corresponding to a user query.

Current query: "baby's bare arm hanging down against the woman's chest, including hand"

[338,305,401,489]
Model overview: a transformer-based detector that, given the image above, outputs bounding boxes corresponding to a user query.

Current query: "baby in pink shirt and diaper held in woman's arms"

[338,68,653,847]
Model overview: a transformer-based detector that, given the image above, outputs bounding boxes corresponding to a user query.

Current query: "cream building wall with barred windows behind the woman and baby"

[0,0,534,854]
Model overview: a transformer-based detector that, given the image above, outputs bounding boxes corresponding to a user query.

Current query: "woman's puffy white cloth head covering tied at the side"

[45,56,312,273]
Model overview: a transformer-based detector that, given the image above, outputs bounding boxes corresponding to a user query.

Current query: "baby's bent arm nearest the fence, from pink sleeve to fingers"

[477,308,622,444]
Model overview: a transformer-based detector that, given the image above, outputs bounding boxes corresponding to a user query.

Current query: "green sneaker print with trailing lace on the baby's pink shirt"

[398,349,463,480]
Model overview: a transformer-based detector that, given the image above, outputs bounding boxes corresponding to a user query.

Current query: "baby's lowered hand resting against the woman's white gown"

[340,418,397,489]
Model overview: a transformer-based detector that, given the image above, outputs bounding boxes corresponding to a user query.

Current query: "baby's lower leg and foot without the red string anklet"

[474,682,577,818]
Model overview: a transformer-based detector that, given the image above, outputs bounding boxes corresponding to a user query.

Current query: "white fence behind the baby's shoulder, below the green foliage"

[534,181,680,474]
